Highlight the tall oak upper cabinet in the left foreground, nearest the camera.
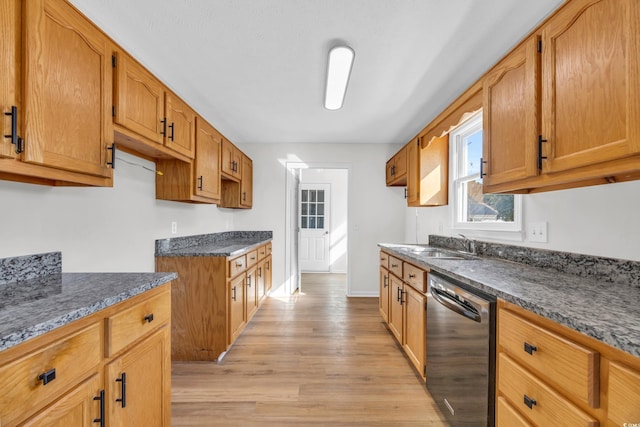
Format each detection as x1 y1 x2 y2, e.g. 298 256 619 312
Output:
0 0 115 186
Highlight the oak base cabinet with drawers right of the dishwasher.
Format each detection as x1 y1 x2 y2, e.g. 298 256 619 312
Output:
496 300 640 426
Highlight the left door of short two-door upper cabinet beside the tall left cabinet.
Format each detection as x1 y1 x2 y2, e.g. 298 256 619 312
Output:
114 52 166 144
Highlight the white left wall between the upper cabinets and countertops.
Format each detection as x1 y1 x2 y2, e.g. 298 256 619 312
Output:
0 151 234 272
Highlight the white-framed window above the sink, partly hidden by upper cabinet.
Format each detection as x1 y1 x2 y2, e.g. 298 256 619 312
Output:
449 112 522 231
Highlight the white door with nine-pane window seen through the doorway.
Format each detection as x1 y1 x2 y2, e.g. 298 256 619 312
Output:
298 183 331 272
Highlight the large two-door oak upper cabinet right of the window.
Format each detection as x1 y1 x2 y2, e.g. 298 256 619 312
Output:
483 0 640 192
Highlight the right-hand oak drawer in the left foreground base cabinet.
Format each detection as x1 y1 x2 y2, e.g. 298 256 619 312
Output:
107 292 171 356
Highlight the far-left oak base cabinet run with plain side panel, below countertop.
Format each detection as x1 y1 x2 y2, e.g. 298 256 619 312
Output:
156 243 272 361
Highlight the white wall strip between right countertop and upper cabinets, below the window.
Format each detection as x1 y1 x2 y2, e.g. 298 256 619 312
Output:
405 181 640 261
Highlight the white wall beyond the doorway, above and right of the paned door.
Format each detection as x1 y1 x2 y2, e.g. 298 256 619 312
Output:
300 169 349 273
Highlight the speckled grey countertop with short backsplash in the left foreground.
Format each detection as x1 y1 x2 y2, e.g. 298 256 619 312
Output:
0 252 177 351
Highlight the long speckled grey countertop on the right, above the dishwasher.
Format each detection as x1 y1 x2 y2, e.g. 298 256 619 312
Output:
379 240 640 357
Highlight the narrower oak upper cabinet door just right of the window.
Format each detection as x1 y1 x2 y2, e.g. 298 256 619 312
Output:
482 36 540 188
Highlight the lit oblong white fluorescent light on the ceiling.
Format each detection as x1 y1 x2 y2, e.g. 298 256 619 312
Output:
324 46 355 110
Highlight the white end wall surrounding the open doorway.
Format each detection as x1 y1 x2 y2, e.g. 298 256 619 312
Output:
234 144 406 296
